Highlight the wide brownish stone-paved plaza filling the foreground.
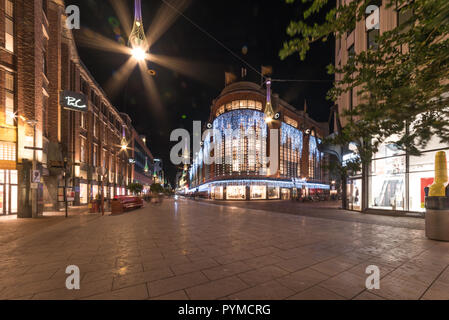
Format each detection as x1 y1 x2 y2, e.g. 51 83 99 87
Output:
0 200 449 300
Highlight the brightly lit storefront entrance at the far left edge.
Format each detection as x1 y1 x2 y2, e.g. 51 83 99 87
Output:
0 170 18 215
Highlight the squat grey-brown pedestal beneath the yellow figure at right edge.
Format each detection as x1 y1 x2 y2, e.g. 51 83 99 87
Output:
425 197 449 241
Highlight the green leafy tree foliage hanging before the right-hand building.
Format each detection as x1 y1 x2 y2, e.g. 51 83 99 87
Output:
280 0 449 163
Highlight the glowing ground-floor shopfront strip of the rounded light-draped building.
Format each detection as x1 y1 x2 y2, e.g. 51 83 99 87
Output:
189 180 330 200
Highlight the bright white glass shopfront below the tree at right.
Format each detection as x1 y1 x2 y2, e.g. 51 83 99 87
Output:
347 139 449 215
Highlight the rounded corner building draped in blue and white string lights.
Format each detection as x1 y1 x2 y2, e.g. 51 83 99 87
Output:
188 81 329 200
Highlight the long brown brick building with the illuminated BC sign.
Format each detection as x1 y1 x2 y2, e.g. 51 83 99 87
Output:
0 0 152 217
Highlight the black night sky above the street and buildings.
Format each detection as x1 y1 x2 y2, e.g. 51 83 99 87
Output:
66 0 334 183
